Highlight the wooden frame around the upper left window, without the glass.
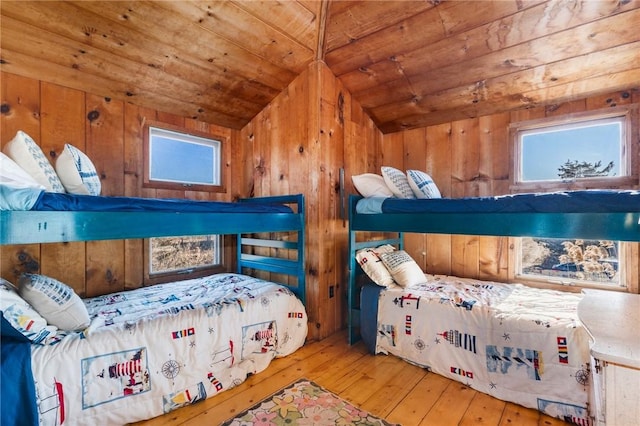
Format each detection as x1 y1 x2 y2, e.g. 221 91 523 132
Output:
142 121 228 193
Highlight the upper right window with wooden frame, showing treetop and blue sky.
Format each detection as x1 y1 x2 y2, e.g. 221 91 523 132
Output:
511 108 632 191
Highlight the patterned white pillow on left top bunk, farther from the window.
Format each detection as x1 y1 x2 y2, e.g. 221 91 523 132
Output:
3 130 64 192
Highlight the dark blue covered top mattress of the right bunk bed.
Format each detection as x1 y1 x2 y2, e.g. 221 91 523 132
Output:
356 190 640 214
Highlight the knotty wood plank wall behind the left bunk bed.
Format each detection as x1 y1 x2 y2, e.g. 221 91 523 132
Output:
0 73 238 297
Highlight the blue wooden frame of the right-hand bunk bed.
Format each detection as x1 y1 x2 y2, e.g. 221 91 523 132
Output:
347 195 640 344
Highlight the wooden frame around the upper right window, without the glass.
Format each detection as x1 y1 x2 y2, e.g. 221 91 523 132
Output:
509 106 638 193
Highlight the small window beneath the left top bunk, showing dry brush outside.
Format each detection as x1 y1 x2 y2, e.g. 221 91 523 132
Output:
145 235 223 283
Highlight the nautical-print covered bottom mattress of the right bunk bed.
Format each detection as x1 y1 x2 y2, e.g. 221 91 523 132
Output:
361 275 590 424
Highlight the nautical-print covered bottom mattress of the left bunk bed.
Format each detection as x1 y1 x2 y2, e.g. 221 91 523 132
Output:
20 274 307 425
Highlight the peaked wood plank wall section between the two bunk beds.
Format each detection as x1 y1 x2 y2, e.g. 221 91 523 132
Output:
240 62 382 339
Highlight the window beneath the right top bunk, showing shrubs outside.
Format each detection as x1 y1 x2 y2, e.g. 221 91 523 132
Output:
516 238 626 289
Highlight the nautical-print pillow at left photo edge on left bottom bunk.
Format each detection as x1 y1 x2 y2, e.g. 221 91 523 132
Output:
0 278 57 344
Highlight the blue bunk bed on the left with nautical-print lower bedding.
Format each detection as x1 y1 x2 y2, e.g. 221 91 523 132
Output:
0 188 307 425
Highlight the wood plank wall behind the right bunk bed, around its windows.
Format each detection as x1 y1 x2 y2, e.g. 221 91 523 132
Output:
382 88 640 291
